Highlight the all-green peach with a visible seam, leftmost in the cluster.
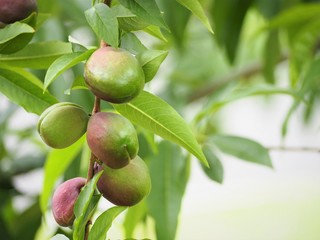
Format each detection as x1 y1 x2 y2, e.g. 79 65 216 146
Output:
38 102 89 148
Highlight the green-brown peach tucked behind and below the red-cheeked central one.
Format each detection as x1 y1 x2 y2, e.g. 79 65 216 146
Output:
95 156 151 206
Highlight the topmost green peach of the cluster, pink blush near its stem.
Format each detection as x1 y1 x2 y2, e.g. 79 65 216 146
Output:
84 47 145 103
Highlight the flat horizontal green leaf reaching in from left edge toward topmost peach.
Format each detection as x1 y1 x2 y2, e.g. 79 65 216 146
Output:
0 41 72 69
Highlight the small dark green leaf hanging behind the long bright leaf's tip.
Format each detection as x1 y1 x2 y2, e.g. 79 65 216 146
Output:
201 145 223 183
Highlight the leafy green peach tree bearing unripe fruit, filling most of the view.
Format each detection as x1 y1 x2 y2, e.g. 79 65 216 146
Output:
0 0 320 240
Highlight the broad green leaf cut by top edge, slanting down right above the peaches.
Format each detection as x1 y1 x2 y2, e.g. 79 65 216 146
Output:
119 0 168 30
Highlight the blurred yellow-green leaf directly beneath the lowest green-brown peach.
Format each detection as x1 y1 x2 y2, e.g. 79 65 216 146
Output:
123 200 147 238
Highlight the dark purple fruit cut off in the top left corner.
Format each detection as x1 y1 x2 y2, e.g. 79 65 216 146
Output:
0 0 38 24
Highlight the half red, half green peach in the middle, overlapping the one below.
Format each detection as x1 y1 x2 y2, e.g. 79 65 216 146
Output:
87 112 139 168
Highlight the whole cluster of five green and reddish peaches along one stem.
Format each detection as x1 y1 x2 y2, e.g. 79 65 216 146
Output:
38 46 151 226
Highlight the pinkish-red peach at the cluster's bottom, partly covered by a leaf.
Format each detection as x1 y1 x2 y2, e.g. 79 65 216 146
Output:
52 177 86 227
